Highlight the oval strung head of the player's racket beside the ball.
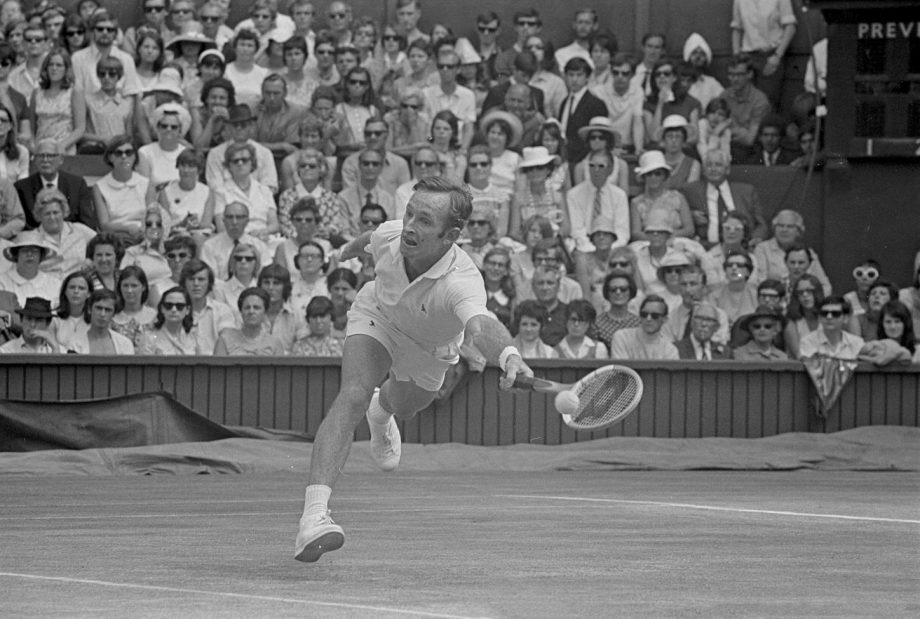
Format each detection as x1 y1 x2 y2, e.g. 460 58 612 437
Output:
560 365 644 432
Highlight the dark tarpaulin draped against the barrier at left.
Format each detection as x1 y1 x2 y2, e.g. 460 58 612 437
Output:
0 393 306 451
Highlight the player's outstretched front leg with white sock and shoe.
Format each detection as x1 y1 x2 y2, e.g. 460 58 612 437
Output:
294 335 390 563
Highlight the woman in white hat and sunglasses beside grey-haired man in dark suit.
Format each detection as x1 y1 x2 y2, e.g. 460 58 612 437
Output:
629 150 696 241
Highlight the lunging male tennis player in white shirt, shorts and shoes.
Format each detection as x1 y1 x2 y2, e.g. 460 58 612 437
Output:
294 177 533 563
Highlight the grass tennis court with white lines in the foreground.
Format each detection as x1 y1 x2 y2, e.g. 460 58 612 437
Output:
0 471 920 617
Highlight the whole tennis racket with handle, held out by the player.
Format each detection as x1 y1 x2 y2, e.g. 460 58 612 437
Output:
514 365 643 431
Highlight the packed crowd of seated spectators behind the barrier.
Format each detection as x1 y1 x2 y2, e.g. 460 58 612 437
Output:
0 0 920 363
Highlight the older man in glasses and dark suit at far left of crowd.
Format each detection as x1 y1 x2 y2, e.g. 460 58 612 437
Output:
14 139 99 230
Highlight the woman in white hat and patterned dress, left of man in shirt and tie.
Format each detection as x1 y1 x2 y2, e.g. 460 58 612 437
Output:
510 146 571 237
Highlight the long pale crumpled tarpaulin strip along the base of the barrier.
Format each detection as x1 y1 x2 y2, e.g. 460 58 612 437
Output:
0 426 920 476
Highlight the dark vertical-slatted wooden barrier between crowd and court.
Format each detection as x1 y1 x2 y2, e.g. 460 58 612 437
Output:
0 355 920 445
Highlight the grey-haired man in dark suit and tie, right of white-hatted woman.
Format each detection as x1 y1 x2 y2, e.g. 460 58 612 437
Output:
681 150 767 249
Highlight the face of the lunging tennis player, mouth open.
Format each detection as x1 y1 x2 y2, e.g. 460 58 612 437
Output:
400 191 460 262
